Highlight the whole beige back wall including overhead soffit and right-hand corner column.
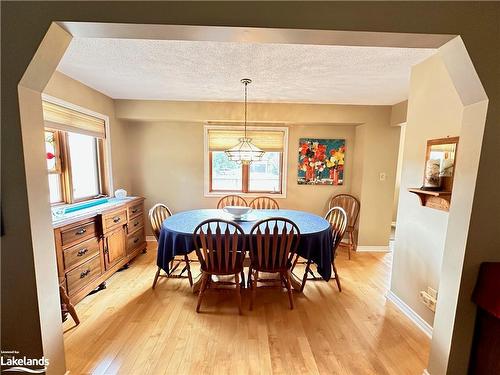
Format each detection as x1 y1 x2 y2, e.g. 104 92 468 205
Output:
116 100 398 246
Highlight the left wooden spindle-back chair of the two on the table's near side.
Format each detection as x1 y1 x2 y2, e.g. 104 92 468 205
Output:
193 219 246 314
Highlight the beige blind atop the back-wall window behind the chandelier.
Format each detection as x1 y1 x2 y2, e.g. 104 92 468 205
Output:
208 128 285 152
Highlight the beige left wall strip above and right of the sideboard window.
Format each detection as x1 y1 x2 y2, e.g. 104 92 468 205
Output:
43 71 130 194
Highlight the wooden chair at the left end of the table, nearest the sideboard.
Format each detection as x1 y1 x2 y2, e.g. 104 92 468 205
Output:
148 203 193 289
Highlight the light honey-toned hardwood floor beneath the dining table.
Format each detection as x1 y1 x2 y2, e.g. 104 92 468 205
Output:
64 243 429 375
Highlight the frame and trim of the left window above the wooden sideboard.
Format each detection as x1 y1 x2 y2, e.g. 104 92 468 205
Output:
42 94 113 207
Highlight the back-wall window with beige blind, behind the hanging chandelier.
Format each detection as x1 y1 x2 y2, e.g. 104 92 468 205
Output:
205 126 287 194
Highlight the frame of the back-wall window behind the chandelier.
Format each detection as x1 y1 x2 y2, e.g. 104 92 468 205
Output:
204 123 288 198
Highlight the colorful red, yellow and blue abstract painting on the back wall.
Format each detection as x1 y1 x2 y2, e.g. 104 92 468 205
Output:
297 138 345 185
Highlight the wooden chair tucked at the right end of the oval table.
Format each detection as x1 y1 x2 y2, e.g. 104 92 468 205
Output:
292 207 347 292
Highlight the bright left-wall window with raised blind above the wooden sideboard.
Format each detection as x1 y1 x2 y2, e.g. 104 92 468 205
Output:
43 102 107 204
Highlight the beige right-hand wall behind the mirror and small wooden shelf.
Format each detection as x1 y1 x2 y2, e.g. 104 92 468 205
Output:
391 55 462 325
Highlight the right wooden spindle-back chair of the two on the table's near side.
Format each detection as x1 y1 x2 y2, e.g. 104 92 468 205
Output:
248 217 300 310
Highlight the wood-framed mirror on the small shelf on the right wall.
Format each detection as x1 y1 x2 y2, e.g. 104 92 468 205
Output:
422 137 458 193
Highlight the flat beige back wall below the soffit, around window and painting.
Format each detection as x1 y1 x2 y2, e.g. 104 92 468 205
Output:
123 122 354 228
